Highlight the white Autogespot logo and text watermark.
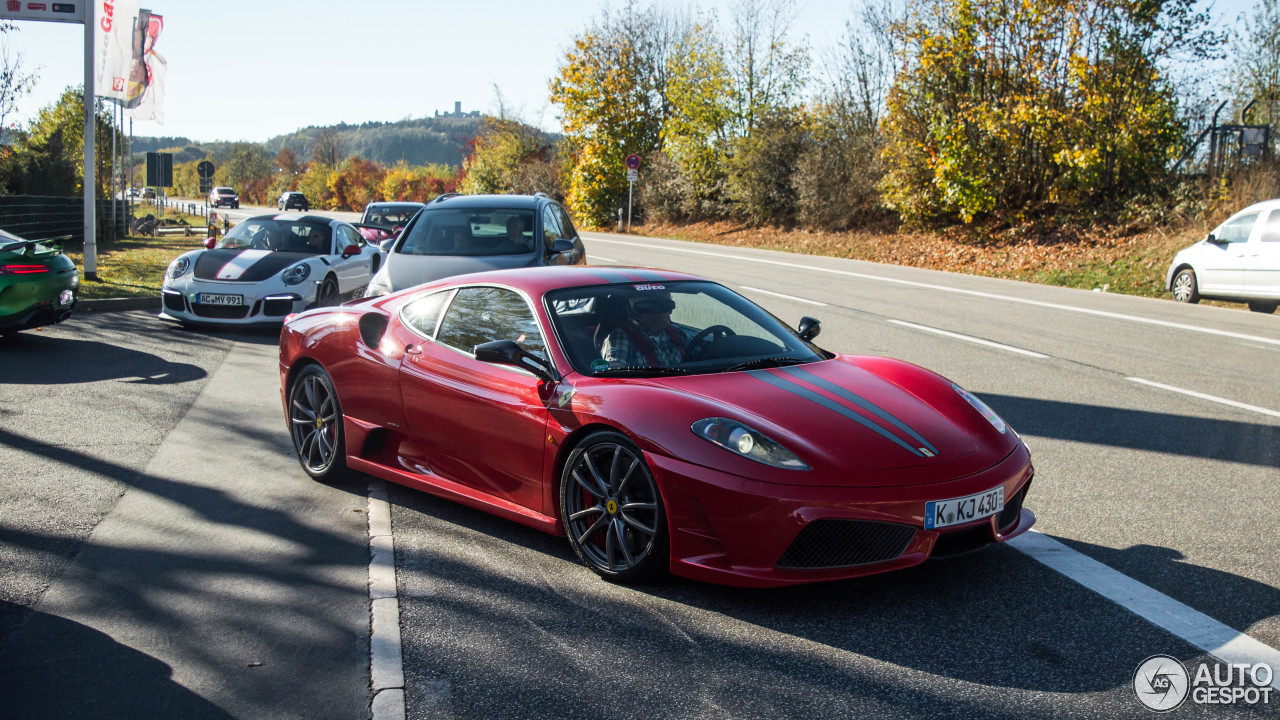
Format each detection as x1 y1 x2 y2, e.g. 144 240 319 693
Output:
1133 655 1275 712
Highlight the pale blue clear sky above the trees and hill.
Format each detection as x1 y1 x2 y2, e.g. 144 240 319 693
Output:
0 0 1253 141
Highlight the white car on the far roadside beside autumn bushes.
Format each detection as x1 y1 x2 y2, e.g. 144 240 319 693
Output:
1165 200 1280 313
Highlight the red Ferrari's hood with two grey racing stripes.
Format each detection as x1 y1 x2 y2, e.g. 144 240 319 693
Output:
645 359 1007 486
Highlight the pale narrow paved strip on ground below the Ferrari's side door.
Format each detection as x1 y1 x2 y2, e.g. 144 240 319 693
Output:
367 478 404 720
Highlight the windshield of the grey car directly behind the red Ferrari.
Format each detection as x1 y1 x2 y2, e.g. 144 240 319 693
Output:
398 208 534 256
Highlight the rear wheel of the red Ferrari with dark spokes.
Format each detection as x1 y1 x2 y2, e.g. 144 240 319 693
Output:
288 365 351 482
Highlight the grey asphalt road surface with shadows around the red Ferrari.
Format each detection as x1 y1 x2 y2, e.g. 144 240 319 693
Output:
0 226 1280 717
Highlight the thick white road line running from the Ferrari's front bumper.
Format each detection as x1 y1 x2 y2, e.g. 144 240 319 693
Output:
1009 530 1280 689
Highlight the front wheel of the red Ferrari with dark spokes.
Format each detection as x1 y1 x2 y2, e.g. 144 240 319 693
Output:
559 432 669 584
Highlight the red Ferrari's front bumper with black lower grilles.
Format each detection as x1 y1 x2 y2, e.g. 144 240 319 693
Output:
646 445 1036 587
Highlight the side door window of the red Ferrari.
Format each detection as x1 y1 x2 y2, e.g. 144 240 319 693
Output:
435 287 547 359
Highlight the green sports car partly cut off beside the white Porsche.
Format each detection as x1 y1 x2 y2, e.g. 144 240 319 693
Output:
0 231 79 334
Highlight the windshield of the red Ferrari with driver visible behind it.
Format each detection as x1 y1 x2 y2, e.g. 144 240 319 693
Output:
545 281 827 377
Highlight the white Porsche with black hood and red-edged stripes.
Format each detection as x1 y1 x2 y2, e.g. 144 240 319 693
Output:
160 214 383 325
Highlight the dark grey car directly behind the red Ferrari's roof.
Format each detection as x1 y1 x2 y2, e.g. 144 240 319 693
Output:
367 193 586 295
